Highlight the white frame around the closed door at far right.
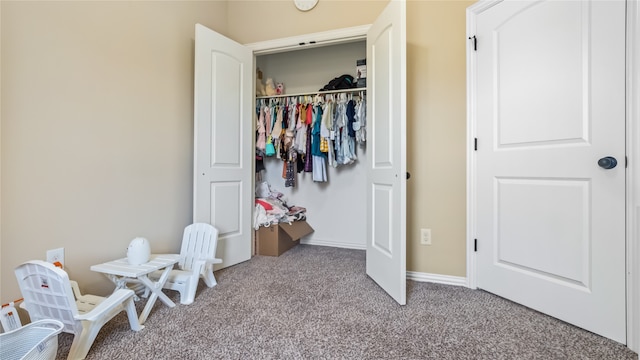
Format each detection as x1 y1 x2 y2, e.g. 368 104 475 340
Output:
466 0 640 353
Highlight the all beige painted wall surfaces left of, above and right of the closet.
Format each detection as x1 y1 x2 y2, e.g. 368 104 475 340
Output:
0 0 472 301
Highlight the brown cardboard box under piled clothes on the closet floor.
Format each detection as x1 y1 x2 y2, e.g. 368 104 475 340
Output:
256 220 313 256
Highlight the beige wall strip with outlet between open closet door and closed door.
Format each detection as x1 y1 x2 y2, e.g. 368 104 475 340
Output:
407 0 475 277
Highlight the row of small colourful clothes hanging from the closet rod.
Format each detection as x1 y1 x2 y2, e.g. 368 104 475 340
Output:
256 92 367 187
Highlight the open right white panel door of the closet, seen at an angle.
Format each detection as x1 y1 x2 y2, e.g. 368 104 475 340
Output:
366 1 407 305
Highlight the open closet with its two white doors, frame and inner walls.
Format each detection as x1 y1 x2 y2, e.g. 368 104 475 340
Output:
193 1 406 304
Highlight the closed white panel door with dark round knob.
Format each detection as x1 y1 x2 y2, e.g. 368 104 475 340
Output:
472 0 626 343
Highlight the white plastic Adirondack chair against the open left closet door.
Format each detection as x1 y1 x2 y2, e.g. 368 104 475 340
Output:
149 223 222 305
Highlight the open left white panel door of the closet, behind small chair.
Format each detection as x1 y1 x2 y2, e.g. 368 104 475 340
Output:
193 24 253 267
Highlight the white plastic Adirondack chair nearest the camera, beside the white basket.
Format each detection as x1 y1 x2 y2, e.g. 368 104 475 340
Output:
15 260 143 359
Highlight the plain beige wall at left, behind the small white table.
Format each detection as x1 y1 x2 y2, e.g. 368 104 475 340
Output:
0 1 227 301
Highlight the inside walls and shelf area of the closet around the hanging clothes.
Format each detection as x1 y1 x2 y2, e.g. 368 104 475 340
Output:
254 40 368 249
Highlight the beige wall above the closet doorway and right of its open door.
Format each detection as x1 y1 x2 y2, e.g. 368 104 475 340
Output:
229 0 474 277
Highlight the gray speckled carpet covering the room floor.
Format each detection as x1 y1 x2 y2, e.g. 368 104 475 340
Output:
57 245 638 359
